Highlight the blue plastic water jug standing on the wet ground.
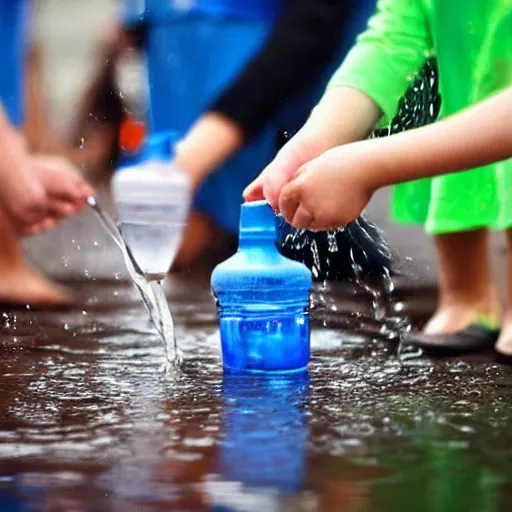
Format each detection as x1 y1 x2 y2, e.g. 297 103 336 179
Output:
211 201 312 372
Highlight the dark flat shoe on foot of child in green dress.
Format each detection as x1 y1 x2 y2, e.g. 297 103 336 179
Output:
403 324 500 356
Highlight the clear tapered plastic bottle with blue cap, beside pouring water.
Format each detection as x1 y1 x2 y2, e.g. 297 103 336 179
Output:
112 134 192 280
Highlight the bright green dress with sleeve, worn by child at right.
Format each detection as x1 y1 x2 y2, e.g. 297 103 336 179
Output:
329 0 512 234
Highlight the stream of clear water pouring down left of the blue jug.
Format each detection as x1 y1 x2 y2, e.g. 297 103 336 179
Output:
88 197 182 369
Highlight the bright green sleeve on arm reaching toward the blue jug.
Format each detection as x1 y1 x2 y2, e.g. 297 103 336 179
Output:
328 0 432 126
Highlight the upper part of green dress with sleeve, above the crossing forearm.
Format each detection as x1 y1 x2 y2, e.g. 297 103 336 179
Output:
329 0 512 127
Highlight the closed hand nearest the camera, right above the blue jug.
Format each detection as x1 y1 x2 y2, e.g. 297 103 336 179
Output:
279 144 375 231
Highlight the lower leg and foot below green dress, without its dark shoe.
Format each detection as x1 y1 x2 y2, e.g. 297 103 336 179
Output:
425 229 501 334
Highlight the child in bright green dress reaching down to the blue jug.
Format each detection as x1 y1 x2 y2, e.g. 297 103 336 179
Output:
245 0 512 352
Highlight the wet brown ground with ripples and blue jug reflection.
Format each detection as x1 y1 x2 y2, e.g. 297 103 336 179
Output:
0 277 512 512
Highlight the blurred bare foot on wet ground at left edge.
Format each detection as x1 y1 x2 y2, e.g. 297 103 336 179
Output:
0 262 70 308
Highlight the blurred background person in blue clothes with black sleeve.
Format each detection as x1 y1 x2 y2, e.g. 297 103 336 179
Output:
67 0 375 269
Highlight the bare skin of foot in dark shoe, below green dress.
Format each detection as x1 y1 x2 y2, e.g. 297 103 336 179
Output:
423 295 502 335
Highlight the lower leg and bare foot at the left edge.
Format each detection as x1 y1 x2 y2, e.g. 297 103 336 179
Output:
0 213 67 306
